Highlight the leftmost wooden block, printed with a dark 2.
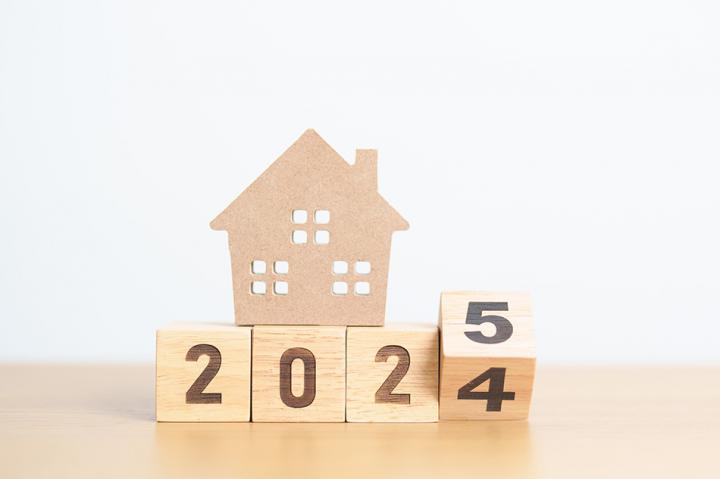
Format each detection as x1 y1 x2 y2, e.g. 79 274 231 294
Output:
155 323 252 422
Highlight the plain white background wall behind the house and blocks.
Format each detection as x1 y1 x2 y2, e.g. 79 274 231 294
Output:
0 0 720 362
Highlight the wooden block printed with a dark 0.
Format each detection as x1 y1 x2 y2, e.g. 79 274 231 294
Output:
252 326 346 422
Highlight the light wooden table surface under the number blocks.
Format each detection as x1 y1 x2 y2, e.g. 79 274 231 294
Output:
0 364 720 479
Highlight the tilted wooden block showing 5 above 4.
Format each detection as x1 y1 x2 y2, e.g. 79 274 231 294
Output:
440 292 535 421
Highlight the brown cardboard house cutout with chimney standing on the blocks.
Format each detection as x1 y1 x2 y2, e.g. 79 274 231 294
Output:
210 130 408 325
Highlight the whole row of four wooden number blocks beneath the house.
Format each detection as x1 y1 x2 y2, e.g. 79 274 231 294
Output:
156 292 535 422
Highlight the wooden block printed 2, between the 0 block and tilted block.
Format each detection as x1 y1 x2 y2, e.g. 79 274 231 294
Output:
346 324 439 422
